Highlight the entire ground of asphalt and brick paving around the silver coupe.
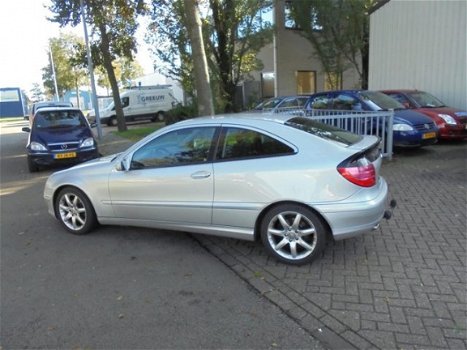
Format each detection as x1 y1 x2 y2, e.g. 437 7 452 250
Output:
1 119 467 349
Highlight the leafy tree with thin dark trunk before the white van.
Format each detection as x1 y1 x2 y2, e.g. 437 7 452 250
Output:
49 0 145 131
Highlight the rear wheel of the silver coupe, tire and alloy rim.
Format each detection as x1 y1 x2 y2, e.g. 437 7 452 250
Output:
261 204 326 265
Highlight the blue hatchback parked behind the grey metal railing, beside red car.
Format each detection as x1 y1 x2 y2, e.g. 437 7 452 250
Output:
306 90 438 147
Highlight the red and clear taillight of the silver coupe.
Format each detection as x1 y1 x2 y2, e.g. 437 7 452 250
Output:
337 158 376 187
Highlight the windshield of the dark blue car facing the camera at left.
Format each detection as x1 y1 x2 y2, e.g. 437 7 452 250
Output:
34 110 86 129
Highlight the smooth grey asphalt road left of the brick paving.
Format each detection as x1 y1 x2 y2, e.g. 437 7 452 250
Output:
0 121 323 350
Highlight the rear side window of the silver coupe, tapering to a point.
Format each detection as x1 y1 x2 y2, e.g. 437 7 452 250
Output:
217 128 294 160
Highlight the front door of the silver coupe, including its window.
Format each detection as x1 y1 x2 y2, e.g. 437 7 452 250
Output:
109 126 216 224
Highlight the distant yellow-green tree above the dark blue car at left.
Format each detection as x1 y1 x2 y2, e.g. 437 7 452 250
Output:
42 33 86 97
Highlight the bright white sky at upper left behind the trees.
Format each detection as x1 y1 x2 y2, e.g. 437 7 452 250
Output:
0 0 157 94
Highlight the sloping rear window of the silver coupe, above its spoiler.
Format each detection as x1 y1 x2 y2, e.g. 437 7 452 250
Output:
285 117 363 146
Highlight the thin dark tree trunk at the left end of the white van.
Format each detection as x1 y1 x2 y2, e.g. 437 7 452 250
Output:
99 24 127 131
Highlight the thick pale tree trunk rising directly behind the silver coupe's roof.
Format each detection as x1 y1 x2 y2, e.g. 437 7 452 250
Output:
184 0 214 116
